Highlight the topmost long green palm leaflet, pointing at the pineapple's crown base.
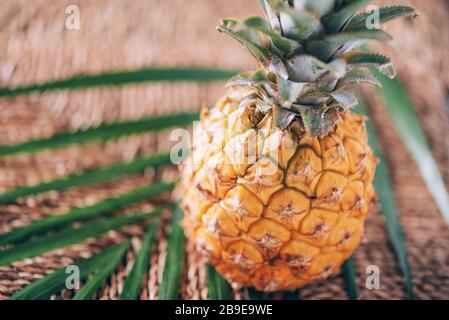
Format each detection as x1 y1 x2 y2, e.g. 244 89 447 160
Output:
0 67 236 97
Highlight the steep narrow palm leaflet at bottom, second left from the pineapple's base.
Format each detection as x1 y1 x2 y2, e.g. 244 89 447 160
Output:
119 218 159 300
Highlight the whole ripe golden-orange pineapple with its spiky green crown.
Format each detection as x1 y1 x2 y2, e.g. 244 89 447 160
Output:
180 0 416 292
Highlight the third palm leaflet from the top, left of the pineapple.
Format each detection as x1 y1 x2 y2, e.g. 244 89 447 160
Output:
0 153 171 203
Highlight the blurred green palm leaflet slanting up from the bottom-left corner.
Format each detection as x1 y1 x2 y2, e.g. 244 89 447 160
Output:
11 242 128 300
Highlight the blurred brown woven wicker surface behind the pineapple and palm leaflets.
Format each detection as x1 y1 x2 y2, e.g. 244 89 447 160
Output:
0 0 449 299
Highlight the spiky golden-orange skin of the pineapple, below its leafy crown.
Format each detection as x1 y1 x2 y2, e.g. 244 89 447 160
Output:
180 88 377 292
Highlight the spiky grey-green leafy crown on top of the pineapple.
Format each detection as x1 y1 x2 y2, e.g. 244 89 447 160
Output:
218 0 417 136
